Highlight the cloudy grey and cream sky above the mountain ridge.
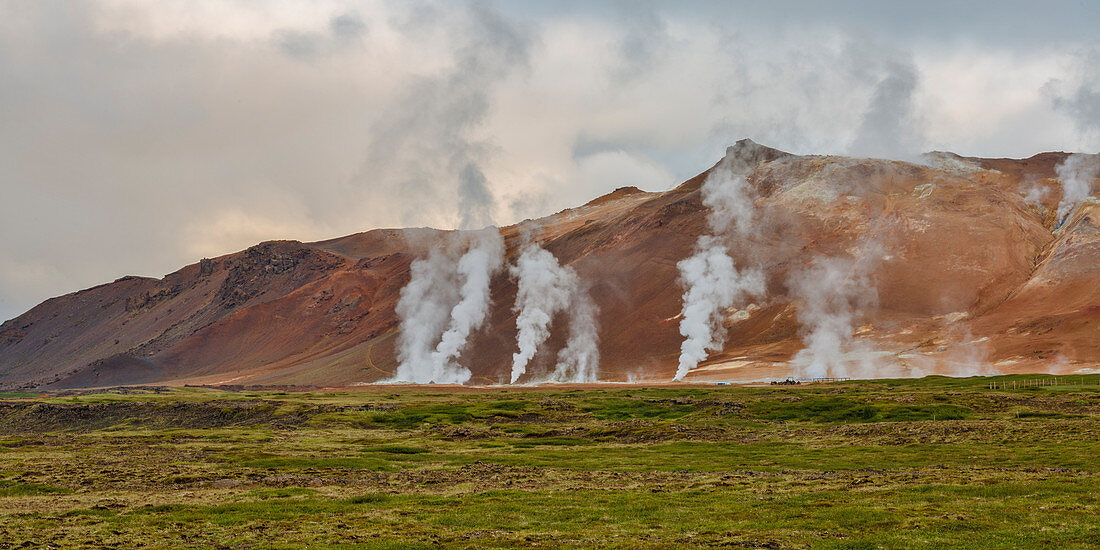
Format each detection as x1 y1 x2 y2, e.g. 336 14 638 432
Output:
0 0 1100 320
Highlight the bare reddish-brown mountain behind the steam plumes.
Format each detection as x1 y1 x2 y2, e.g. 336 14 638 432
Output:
0 140 1100 388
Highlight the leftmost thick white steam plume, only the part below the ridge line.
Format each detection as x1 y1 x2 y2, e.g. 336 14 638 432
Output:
393 228 504 384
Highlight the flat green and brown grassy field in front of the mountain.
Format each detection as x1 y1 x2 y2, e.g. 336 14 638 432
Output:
0 375 1100 549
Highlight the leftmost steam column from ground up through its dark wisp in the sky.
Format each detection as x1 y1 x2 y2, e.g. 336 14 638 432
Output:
385 32 508 384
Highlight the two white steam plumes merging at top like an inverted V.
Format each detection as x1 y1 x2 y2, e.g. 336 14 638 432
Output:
510 243 600 383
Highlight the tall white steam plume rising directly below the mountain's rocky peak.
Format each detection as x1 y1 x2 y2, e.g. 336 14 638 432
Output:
673 156 765 381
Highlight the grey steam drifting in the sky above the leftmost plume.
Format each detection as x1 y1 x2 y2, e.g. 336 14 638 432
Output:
356 2 529 229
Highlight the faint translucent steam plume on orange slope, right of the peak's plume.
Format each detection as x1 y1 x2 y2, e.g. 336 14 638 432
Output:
788 246 881 378
